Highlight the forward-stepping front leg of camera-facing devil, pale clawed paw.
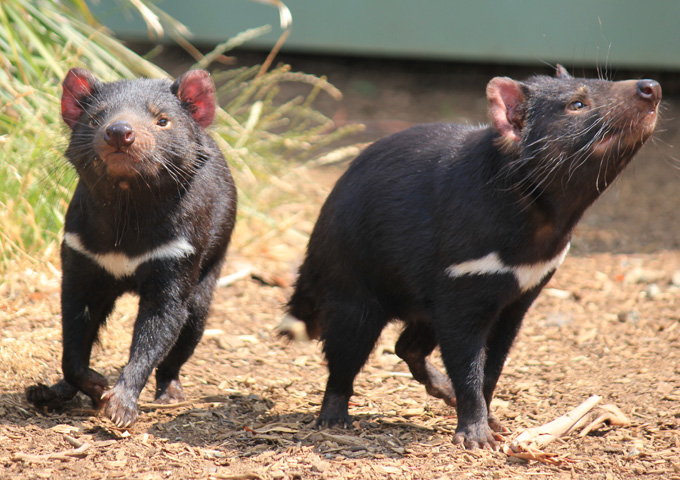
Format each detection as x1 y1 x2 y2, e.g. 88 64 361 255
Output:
102 275 188 428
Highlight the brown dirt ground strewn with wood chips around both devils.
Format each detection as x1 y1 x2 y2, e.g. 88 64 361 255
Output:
0 55 680 480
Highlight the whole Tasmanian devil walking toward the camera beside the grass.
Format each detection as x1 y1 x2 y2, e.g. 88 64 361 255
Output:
26 69 236 427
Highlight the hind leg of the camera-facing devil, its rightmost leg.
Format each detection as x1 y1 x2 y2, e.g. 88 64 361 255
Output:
155 265 220 404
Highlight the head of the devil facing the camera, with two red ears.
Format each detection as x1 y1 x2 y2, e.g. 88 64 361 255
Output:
61 68 216 195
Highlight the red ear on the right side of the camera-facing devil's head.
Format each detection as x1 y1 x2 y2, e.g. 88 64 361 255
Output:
171 70 215 128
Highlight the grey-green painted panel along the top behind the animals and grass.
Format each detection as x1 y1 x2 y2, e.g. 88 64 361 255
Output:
93 0 680 69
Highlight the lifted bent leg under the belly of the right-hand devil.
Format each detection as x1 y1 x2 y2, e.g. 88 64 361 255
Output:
395 321 456 407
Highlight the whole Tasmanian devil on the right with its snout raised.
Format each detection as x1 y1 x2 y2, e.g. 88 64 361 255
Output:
282 66 661 448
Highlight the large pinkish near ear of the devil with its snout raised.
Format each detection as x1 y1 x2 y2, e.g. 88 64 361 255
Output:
486 77 526 143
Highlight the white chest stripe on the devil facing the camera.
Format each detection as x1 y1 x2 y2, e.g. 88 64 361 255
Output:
64 233 195 278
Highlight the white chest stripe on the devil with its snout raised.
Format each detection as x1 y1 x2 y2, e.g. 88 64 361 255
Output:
446 244 569 292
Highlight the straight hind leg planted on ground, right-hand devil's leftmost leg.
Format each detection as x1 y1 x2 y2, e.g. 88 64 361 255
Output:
316 302 387 427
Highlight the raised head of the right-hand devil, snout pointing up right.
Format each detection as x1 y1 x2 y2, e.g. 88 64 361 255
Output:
486 65 661 194
